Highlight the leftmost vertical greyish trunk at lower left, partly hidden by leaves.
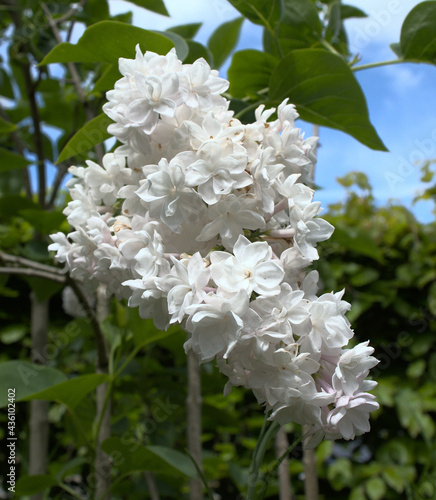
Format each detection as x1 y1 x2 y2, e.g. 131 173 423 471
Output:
29 292 49 500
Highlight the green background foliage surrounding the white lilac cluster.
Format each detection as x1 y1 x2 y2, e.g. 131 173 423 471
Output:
0 0 436 500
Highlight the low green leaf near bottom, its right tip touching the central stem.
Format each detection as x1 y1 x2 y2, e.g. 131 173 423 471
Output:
102 437 196 477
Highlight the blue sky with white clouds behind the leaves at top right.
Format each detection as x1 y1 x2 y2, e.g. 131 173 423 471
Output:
109 0 436 222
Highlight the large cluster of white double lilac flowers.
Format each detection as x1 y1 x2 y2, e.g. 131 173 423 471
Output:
50 49 378 441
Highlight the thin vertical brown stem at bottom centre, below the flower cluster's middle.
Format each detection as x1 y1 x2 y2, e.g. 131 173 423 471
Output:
186 349 203 500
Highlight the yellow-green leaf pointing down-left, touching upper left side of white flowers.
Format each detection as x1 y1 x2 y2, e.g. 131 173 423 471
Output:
57 113 112 163
